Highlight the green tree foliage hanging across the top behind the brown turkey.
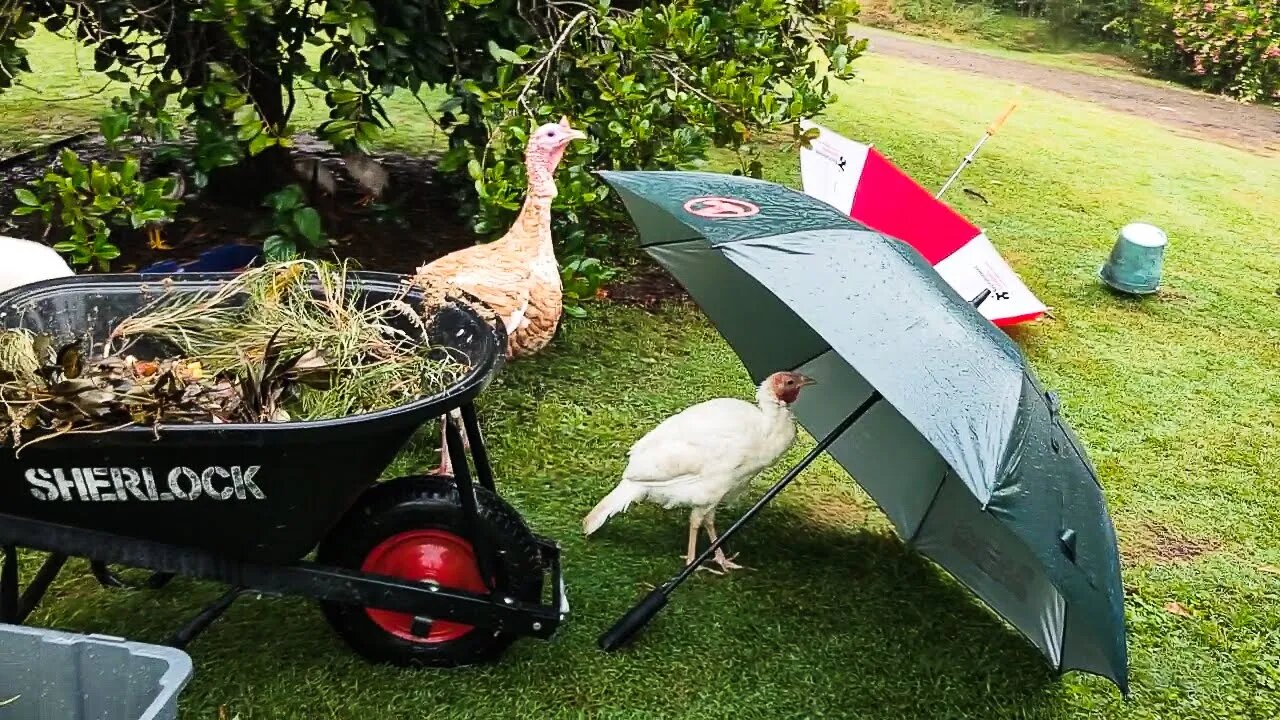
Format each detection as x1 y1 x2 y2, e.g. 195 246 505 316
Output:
0 0 863 274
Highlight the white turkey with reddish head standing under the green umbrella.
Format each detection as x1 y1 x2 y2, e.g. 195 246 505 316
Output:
582 373 814 570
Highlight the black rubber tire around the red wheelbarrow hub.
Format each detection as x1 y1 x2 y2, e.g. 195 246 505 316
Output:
316 475 544 667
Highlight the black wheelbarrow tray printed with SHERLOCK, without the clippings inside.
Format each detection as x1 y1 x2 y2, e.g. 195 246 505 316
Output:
0 272 504 564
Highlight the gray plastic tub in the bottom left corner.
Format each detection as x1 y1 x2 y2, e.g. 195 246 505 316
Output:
0 625 191 720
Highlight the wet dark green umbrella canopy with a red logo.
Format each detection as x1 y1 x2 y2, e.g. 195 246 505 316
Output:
600 166 1128 692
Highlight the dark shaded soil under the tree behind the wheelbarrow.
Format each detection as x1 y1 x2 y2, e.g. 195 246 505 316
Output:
0 131 476 273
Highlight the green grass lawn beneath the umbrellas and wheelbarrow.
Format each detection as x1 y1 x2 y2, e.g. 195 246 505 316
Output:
0 29 1280 720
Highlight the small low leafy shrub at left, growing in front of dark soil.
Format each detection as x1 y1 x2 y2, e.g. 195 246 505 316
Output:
13 150 179 270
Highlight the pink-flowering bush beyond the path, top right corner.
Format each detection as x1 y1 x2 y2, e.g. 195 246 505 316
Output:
1129 0 1280 101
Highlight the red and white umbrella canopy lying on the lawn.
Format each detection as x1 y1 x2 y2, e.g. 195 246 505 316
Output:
800 120 1046 325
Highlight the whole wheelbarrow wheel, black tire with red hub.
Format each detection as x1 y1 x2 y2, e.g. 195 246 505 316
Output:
316 475 543 667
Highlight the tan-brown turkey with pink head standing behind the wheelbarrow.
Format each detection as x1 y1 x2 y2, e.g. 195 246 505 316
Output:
413 118 586 475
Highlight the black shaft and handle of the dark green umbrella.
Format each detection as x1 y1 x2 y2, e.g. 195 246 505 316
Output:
599 391 884 651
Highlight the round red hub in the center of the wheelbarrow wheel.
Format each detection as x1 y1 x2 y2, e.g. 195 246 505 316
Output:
360 530 485 643
